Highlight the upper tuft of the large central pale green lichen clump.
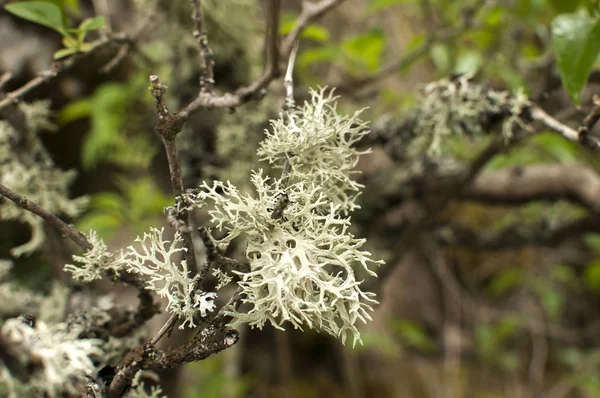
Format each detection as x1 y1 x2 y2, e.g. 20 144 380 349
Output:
258 88 369 215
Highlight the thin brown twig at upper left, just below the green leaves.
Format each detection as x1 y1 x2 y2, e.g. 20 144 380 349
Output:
0 33 131 110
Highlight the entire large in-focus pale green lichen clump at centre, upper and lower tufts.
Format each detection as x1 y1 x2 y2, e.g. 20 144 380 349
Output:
186 90 380 343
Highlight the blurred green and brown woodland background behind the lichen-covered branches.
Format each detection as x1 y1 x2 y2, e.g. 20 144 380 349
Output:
0 0 600 398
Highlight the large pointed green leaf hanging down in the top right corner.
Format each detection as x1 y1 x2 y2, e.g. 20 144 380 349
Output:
551 14 600 105
